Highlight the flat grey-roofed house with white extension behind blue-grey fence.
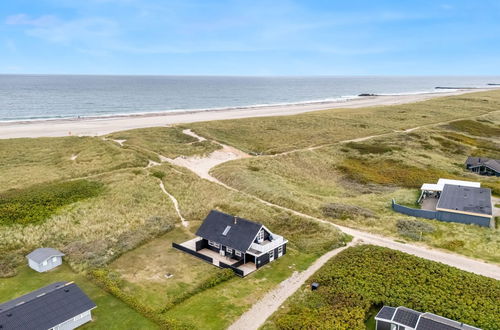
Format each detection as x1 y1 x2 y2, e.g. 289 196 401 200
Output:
392 179 494 227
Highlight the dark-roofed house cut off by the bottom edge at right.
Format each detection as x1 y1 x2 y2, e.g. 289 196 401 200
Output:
375 306 480 330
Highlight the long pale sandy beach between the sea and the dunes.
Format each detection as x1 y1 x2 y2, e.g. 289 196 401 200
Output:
0 89 487 139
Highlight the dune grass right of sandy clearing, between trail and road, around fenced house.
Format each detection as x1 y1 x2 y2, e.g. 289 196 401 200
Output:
212 122 500 263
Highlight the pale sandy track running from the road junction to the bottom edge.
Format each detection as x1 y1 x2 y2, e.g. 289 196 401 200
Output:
228 240 357 330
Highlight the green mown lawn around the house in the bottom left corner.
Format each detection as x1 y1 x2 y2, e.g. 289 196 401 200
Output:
0 264 158 329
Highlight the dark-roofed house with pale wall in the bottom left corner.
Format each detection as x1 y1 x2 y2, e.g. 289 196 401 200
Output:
0 282 97 330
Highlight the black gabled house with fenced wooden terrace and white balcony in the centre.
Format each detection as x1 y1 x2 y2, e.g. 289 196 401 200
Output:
173 210 288 276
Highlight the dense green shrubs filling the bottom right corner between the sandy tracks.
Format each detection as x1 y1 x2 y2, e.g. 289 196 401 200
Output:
263 245 500 330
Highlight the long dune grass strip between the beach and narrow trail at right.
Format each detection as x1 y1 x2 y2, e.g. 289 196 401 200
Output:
186 91 500 154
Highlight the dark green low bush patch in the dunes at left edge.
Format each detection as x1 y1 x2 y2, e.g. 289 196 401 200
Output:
0 180 103 225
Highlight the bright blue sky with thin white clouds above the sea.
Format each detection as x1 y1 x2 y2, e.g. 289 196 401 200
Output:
0 0 500 76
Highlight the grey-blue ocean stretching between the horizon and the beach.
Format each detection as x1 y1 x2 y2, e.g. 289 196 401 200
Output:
0 75 500 121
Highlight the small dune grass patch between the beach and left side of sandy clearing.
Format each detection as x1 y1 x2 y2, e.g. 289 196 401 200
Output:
107 127 220 160
